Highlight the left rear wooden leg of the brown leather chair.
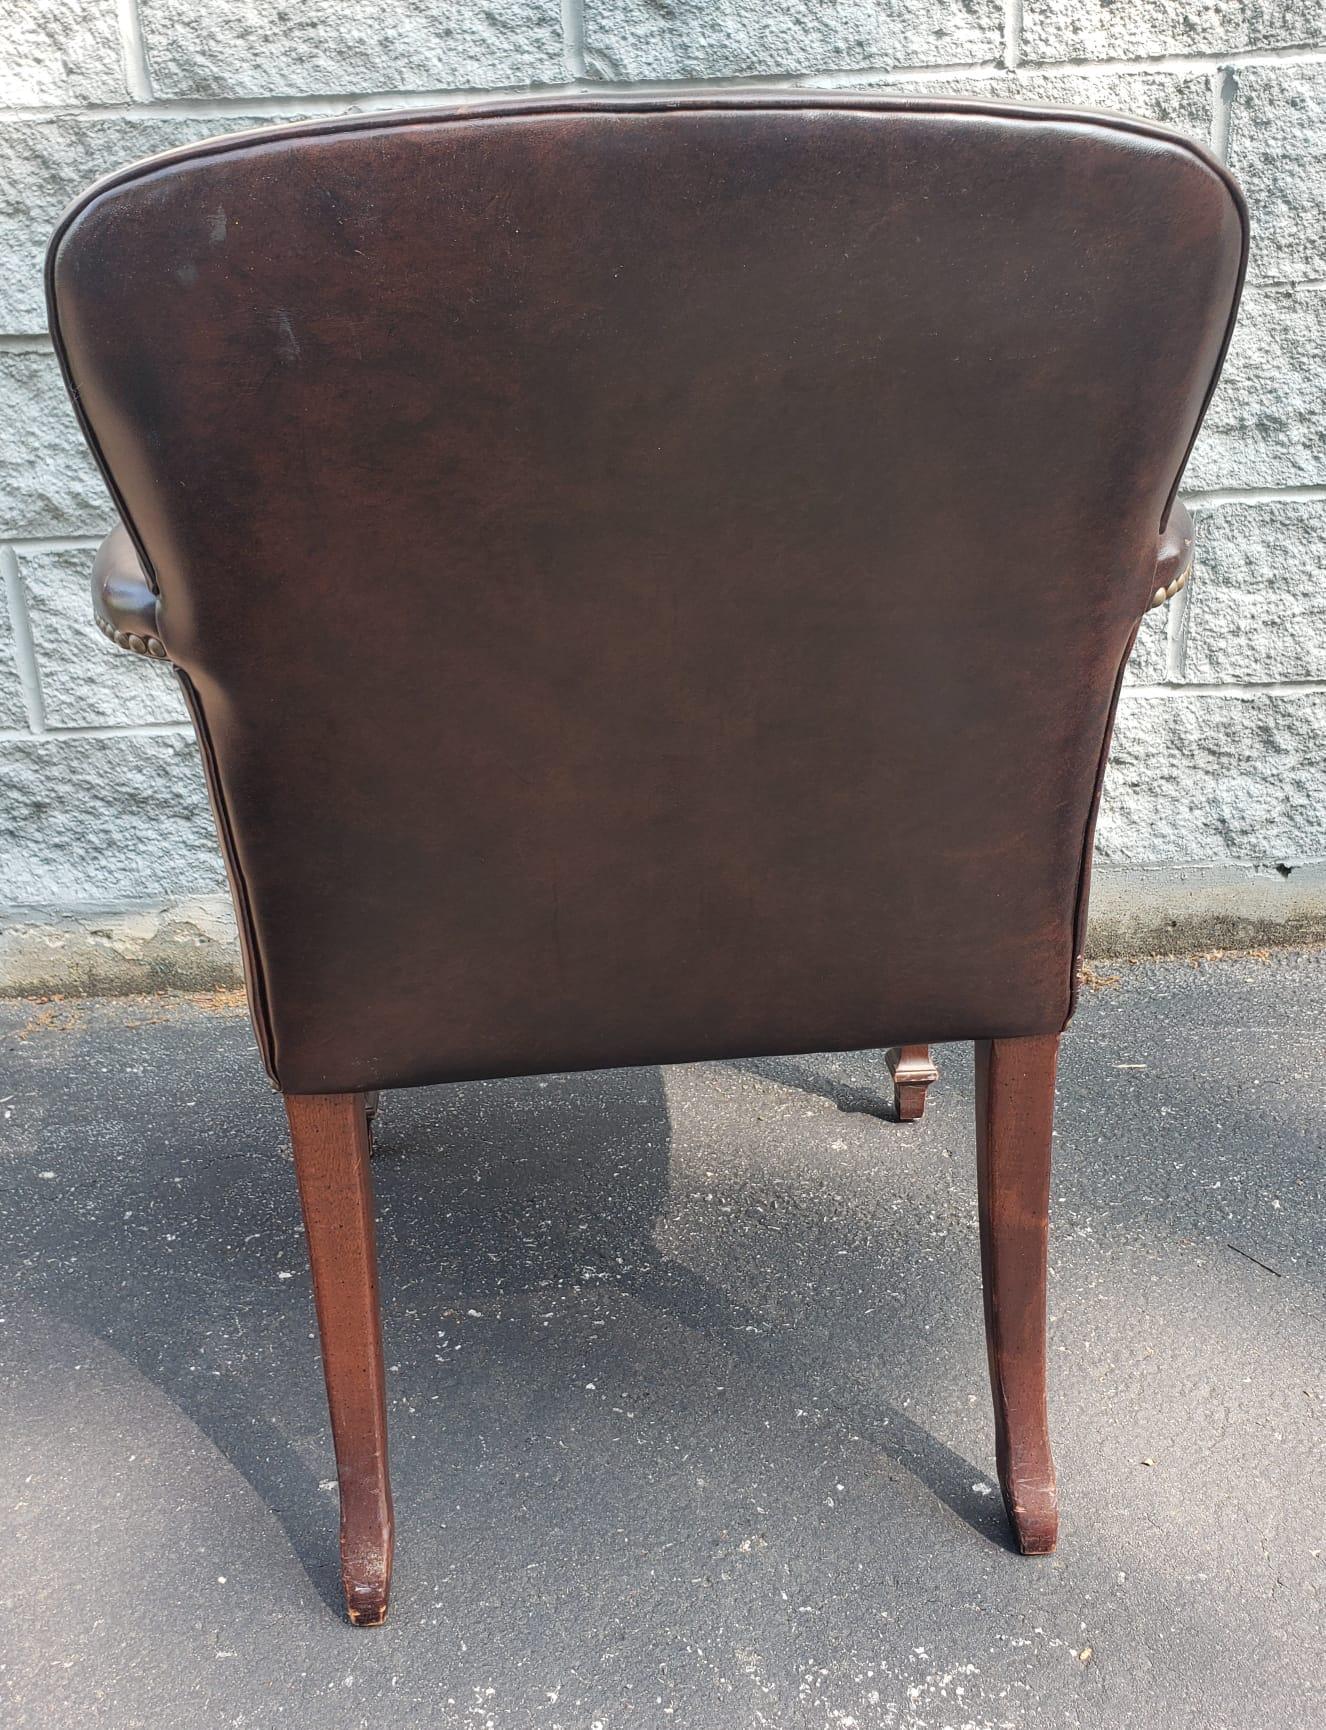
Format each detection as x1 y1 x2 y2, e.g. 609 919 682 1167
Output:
286 1093 393 1628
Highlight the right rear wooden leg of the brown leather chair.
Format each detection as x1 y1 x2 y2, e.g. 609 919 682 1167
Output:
976 1035 1059 1555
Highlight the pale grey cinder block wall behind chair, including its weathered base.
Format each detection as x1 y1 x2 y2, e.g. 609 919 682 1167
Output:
0 0 1326 988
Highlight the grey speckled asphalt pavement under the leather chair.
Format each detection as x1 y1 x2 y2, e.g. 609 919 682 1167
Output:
0 952 1326 1730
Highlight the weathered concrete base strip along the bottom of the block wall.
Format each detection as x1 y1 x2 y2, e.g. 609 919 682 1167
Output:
0 862 1326 996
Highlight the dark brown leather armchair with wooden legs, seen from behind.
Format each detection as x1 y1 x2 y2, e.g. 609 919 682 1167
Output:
48 93 1246 1623
